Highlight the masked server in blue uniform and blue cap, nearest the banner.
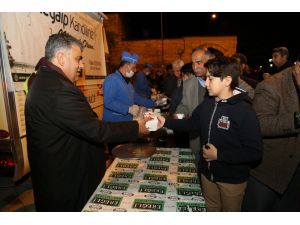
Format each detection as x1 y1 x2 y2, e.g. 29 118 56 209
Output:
103 51 156 121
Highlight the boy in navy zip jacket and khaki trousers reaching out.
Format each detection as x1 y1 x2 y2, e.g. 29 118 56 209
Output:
158 57 262 211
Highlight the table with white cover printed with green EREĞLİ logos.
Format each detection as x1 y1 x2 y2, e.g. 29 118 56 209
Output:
82 147 206 212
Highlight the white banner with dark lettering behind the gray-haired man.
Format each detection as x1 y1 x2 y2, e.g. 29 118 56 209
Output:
0 12 106 79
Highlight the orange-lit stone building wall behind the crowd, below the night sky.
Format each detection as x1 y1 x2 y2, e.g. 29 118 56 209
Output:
104 13 237 72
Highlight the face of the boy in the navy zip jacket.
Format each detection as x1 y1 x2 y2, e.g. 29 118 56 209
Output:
205 74 228 97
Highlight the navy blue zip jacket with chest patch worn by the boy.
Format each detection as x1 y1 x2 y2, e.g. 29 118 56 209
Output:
165 93 263 184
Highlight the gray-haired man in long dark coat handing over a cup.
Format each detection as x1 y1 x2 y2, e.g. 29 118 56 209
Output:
25 34 147 211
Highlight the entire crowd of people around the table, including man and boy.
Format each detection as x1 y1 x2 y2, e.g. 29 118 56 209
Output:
25 34 300 211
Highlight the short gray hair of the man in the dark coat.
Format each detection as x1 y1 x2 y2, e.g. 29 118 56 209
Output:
45 33 83 61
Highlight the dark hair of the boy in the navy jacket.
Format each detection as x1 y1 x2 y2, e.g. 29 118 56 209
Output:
204 56 241 90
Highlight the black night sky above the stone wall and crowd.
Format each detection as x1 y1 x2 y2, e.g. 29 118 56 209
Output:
121 12 300 67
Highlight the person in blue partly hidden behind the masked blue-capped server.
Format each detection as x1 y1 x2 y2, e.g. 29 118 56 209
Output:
134 63 152 98
